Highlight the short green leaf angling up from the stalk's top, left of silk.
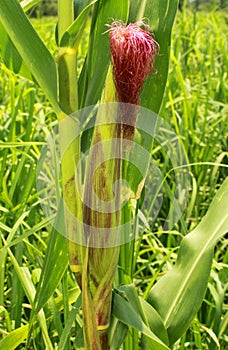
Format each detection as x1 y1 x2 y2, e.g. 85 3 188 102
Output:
60 0 97 50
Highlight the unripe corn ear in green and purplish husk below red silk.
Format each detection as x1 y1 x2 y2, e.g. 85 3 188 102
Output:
82 69 121 349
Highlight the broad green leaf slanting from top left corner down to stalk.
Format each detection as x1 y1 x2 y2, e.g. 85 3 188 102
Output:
0 0 60 112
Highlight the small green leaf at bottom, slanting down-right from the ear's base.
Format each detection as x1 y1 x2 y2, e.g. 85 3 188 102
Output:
113 291 169 350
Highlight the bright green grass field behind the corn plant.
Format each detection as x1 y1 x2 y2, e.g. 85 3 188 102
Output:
0 6 228 350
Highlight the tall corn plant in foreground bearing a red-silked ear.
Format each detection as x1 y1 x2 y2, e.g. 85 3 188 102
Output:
0 0 228 350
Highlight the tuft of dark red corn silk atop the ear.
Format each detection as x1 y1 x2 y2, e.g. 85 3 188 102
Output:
109 22 159 139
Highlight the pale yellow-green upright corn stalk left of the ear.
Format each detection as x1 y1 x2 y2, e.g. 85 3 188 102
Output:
58 0 80 279
